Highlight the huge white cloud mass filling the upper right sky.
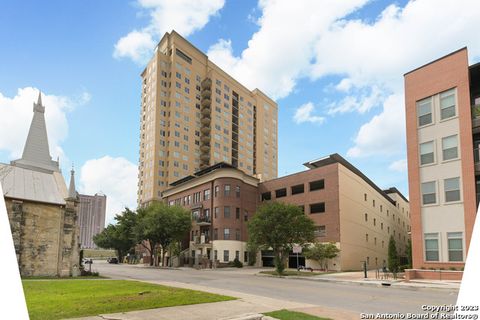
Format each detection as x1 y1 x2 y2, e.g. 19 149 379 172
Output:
208 0 480 156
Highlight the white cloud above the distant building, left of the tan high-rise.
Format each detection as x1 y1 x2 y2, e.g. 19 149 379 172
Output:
78 156 138 223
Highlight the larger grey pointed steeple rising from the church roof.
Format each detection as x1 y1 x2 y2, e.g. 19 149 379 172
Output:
12 92 60 172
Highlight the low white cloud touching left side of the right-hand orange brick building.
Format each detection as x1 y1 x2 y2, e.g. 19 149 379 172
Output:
347 94 405 157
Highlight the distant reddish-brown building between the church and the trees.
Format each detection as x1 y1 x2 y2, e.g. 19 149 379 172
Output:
78 193 107 249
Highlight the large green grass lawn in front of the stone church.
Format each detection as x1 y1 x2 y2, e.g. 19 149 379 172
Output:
23 280 235 320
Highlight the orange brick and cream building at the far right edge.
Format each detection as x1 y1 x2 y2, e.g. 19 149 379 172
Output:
405 48 480 279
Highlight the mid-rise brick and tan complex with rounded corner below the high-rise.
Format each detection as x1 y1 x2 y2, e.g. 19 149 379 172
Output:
163 154 410 270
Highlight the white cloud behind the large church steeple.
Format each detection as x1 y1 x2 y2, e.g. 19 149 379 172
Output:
0 87 91 162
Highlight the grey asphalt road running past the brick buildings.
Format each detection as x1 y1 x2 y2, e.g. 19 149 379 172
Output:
92 261 458 313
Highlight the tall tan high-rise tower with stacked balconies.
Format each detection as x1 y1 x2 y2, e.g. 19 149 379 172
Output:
138 31 278 204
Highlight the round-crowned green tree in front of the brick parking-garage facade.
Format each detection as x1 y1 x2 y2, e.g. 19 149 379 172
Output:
248 201 315 274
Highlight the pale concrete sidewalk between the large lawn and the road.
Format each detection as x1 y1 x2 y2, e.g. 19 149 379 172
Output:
71 281 358 320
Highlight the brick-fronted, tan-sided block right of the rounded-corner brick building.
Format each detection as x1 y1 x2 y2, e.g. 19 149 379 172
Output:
258 154 410 270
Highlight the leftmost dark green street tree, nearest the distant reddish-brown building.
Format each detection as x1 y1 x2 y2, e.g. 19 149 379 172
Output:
93 208 137 261
